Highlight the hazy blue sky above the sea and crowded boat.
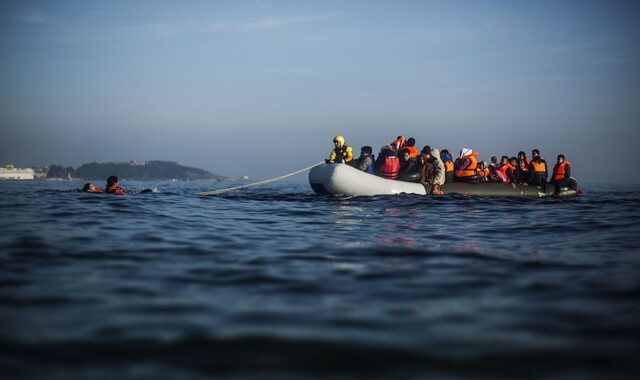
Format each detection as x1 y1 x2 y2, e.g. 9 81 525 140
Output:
0 0 640 183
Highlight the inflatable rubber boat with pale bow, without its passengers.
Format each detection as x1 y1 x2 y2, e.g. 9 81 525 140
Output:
309 164 578 198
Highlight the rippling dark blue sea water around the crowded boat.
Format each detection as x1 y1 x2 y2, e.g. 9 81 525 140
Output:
0 181 640 379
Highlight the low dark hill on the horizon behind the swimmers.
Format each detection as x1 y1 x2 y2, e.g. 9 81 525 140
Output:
47 161 225 181
